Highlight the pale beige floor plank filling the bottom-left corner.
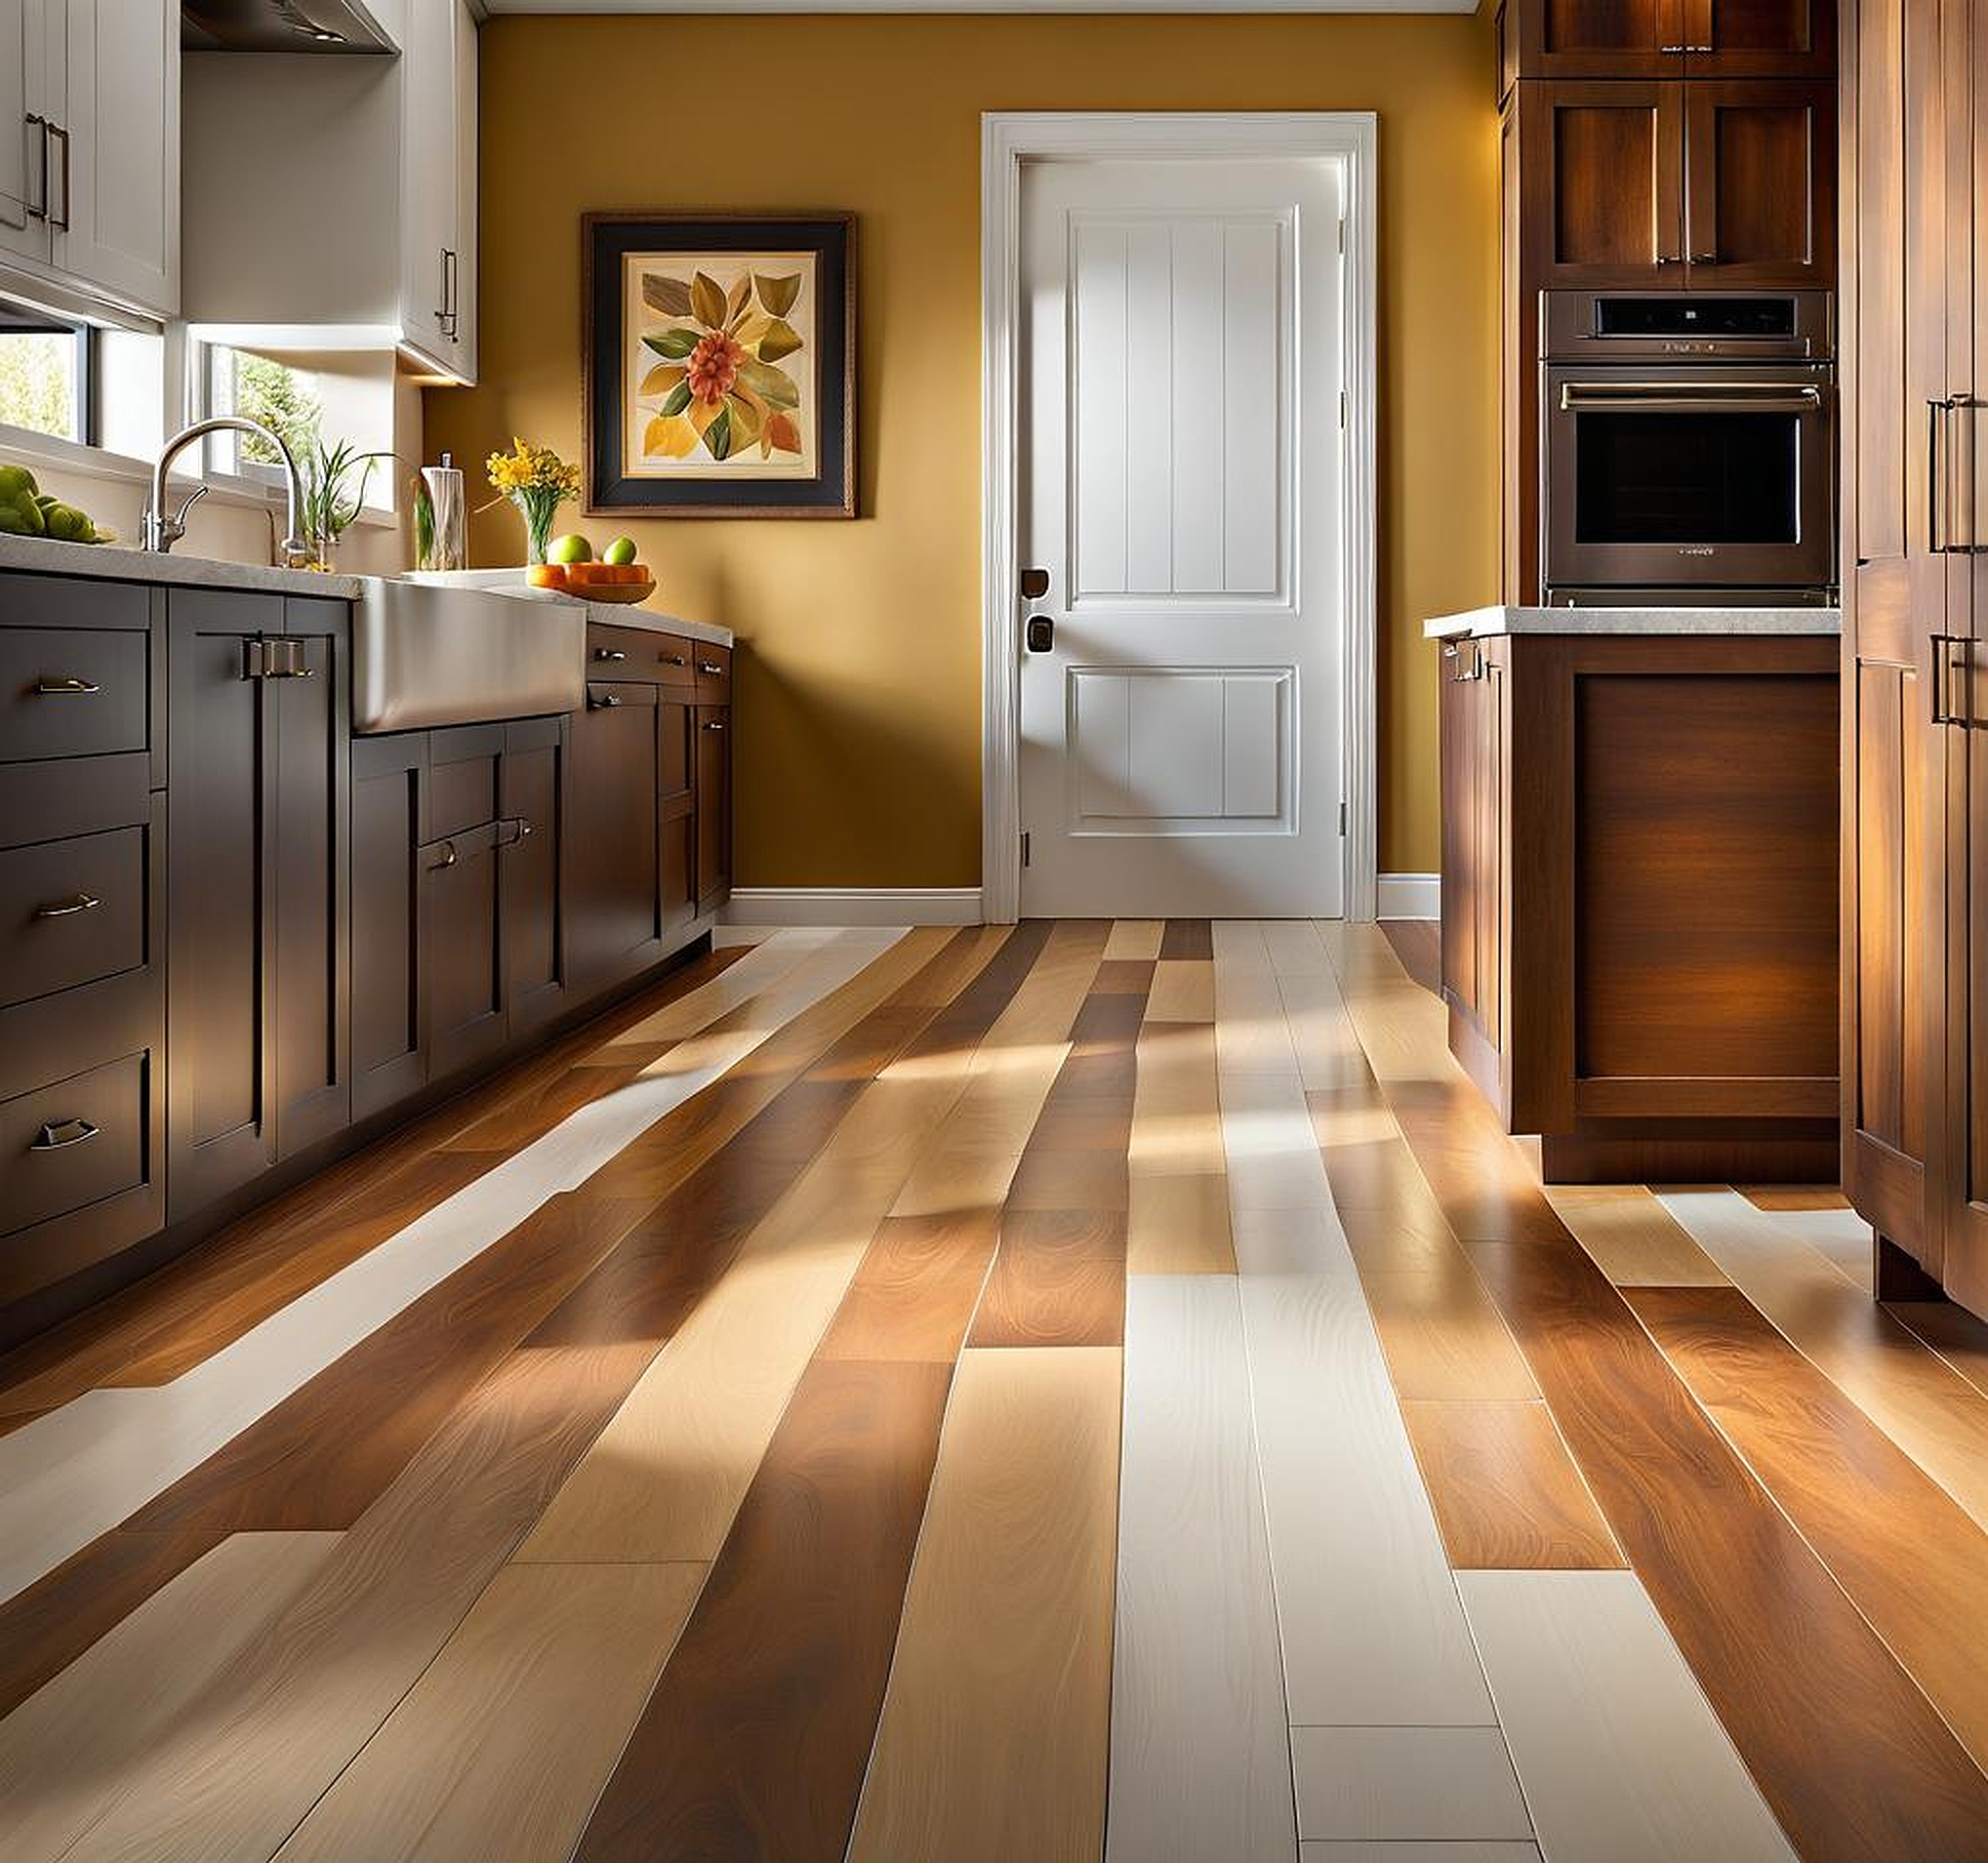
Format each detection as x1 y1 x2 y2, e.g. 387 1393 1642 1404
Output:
0 1533 342 1863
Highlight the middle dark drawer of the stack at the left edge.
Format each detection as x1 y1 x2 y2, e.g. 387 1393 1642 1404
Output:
0 828 147 1008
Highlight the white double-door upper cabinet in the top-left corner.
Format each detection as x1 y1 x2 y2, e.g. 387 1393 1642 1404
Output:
0 0 179 316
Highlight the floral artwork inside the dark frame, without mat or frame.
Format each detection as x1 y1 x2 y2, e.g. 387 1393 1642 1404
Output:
623 253 819 479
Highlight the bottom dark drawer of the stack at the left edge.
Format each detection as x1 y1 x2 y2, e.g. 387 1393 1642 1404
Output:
0 1054 147 1235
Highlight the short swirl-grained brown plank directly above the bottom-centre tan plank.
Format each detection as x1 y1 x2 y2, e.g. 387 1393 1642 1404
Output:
968 1216 1125 1346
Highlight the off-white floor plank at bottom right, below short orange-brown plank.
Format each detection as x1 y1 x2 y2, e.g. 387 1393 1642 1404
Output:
1457 1573 1793 1863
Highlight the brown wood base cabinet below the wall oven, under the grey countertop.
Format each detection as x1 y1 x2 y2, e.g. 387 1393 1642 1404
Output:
1441 610 1839 1183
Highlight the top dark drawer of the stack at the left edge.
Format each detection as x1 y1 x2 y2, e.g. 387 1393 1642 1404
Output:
0 628 151 763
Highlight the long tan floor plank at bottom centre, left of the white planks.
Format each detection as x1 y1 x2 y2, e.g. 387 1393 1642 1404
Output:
849 1346 1121 1863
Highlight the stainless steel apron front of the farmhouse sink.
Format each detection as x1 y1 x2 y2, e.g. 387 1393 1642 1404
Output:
352 577 587 732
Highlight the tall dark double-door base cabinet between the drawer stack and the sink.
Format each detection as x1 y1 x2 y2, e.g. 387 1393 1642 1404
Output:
167 588 352 1219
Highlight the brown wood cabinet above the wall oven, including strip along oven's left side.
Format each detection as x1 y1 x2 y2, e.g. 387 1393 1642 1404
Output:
1499 0 1837 602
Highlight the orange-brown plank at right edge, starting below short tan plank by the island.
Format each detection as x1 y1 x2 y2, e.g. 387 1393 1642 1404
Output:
1624 1286 1988 1763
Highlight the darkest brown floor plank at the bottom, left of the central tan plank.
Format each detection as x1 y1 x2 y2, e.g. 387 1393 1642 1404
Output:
575 1360 951 1863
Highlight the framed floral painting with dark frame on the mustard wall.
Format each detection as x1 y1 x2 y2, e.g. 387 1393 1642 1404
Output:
583 213 857 517
